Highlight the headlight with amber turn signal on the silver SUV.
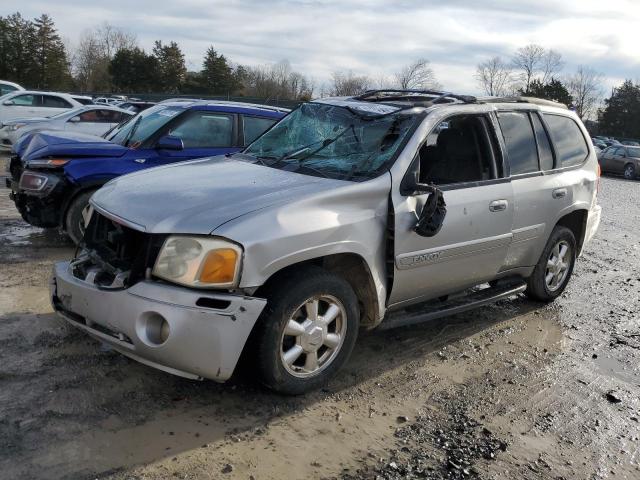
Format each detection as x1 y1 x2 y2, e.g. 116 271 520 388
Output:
153 236 242 288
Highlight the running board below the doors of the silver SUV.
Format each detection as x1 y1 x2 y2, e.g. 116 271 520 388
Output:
378 281 527 330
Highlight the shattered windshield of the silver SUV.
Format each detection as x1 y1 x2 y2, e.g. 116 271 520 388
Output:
239 103 417 181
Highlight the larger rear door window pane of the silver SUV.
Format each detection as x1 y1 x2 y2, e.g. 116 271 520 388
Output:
498 112 539 175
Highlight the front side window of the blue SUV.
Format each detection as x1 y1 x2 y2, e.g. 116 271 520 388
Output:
169 112 234 148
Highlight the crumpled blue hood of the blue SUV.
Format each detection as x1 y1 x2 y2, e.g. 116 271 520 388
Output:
14 130 129 160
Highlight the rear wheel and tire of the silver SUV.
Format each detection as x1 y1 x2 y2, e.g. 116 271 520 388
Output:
525 226 577 303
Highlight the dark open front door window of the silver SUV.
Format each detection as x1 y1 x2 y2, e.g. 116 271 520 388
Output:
418 115 501 185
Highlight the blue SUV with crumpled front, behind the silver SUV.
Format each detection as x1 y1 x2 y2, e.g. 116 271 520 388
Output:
7 101 286 242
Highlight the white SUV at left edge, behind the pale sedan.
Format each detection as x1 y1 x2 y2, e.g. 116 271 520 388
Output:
0 90 82 123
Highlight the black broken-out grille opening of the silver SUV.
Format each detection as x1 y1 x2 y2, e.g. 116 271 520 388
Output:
73 211 166 289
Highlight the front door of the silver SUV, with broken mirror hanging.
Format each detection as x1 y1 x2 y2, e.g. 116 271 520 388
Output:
389 114 513 306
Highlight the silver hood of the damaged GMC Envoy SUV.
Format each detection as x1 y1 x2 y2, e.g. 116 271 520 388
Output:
91 156 350 235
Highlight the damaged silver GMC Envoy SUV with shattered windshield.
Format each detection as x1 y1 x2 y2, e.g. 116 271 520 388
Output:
52 90 601 394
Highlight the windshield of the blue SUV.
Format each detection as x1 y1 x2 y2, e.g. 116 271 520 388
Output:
106 105 185 148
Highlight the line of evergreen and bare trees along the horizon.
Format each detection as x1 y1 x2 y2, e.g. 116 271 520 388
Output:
0 13 640 138
